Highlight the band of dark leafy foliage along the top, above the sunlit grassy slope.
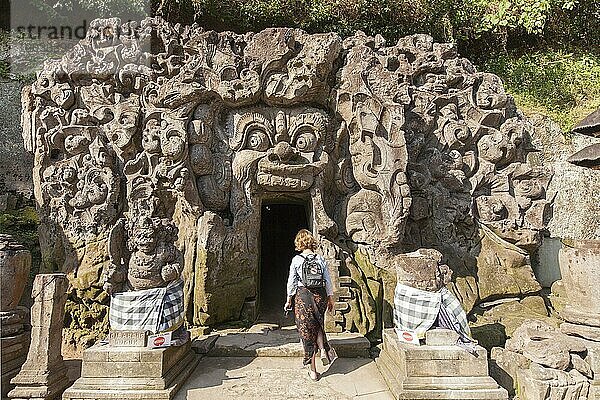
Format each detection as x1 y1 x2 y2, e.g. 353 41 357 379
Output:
153 0 600 53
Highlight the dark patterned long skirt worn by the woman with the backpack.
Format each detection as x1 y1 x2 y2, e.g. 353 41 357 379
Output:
294 286 329 365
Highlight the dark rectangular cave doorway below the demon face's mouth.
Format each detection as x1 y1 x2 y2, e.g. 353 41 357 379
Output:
258 203 310 326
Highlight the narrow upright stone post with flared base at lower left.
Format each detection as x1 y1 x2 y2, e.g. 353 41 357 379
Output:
8 273 70 400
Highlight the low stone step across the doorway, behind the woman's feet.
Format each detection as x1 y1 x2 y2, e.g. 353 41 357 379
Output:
192 329 371 358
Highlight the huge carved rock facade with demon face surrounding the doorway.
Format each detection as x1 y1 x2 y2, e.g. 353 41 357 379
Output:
23 18 550 340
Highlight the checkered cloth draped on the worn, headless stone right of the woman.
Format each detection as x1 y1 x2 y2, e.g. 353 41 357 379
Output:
394 284 471 338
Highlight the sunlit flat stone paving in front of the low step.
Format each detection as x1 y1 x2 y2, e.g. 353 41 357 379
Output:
175 357 393 400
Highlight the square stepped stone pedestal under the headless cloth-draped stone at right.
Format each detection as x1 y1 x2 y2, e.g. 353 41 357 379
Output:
375 329 508 400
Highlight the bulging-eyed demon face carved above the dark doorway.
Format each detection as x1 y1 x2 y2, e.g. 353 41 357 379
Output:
218 107 337 235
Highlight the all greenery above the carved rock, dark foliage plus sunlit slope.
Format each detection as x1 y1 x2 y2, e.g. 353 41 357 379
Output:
0 0 600 129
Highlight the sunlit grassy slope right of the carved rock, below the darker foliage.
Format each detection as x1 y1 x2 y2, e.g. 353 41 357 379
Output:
480 50 600 131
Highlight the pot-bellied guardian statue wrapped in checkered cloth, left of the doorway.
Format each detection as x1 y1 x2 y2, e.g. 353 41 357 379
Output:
103 214 189 334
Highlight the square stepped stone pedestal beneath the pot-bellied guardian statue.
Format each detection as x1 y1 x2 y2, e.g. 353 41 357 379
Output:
62 342 198 400
